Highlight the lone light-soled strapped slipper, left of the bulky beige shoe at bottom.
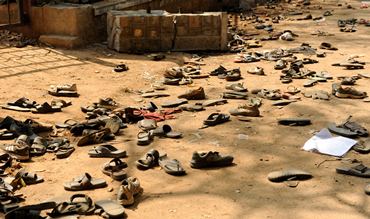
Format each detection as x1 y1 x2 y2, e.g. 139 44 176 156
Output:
64 173 107 191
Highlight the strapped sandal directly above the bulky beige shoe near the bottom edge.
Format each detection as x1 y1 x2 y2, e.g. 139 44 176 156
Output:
102 158 127 181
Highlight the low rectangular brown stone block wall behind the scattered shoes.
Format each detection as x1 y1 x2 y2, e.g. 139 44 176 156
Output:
107 10 227 52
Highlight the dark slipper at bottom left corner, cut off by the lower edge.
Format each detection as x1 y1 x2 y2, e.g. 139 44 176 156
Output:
5 202 56 219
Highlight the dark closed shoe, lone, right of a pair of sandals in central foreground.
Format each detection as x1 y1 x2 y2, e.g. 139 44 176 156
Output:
190 151 234 169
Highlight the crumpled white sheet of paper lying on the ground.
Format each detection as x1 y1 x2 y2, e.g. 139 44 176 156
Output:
303 128 357 157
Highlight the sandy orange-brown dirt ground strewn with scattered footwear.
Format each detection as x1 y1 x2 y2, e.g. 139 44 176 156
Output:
0 1 370 218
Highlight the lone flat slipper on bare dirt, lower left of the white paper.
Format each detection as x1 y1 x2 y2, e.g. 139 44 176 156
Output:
267 169 312 182
